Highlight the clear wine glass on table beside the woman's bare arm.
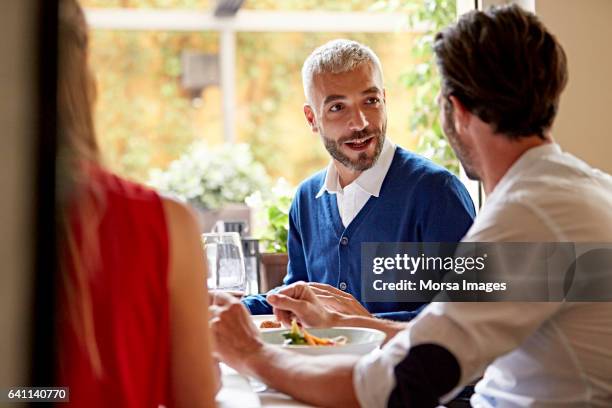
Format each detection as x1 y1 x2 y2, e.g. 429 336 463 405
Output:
202 232 246 293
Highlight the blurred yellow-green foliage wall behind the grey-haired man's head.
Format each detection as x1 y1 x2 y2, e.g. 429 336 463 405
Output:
83 0 458 185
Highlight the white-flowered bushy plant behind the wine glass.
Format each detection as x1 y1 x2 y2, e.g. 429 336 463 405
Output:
148 142 270 231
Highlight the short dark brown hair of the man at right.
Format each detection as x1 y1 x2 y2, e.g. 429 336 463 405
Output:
434 5 568 138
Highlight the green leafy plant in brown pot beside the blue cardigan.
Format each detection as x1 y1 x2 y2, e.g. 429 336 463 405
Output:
245 179 294 293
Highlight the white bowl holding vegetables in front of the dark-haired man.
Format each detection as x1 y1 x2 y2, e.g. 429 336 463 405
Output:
261 327 386 355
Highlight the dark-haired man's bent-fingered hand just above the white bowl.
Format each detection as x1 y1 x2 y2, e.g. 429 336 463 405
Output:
267 282 338 327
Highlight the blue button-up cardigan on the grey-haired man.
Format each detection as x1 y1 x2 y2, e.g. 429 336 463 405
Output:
243 146 475 321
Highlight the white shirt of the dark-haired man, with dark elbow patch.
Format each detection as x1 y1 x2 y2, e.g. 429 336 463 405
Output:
353 144 612 408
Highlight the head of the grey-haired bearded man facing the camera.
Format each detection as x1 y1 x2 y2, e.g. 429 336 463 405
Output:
302 40 387 171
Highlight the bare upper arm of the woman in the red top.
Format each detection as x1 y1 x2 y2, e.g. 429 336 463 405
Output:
163 199 220 407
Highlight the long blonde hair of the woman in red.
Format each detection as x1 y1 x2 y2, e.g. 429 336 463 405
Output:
57 0 104 377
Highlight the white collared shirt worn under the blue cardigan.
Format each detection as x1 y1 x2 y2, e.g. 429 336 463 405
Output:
316 138 395 228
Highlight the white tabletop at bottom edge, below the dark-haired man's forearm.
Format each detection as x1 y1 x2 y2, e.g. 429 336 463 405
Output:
217 363 312 408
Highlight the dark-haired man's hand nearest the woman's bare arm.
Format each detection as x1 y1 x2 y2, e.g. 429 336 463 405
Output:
209 293 263 371
